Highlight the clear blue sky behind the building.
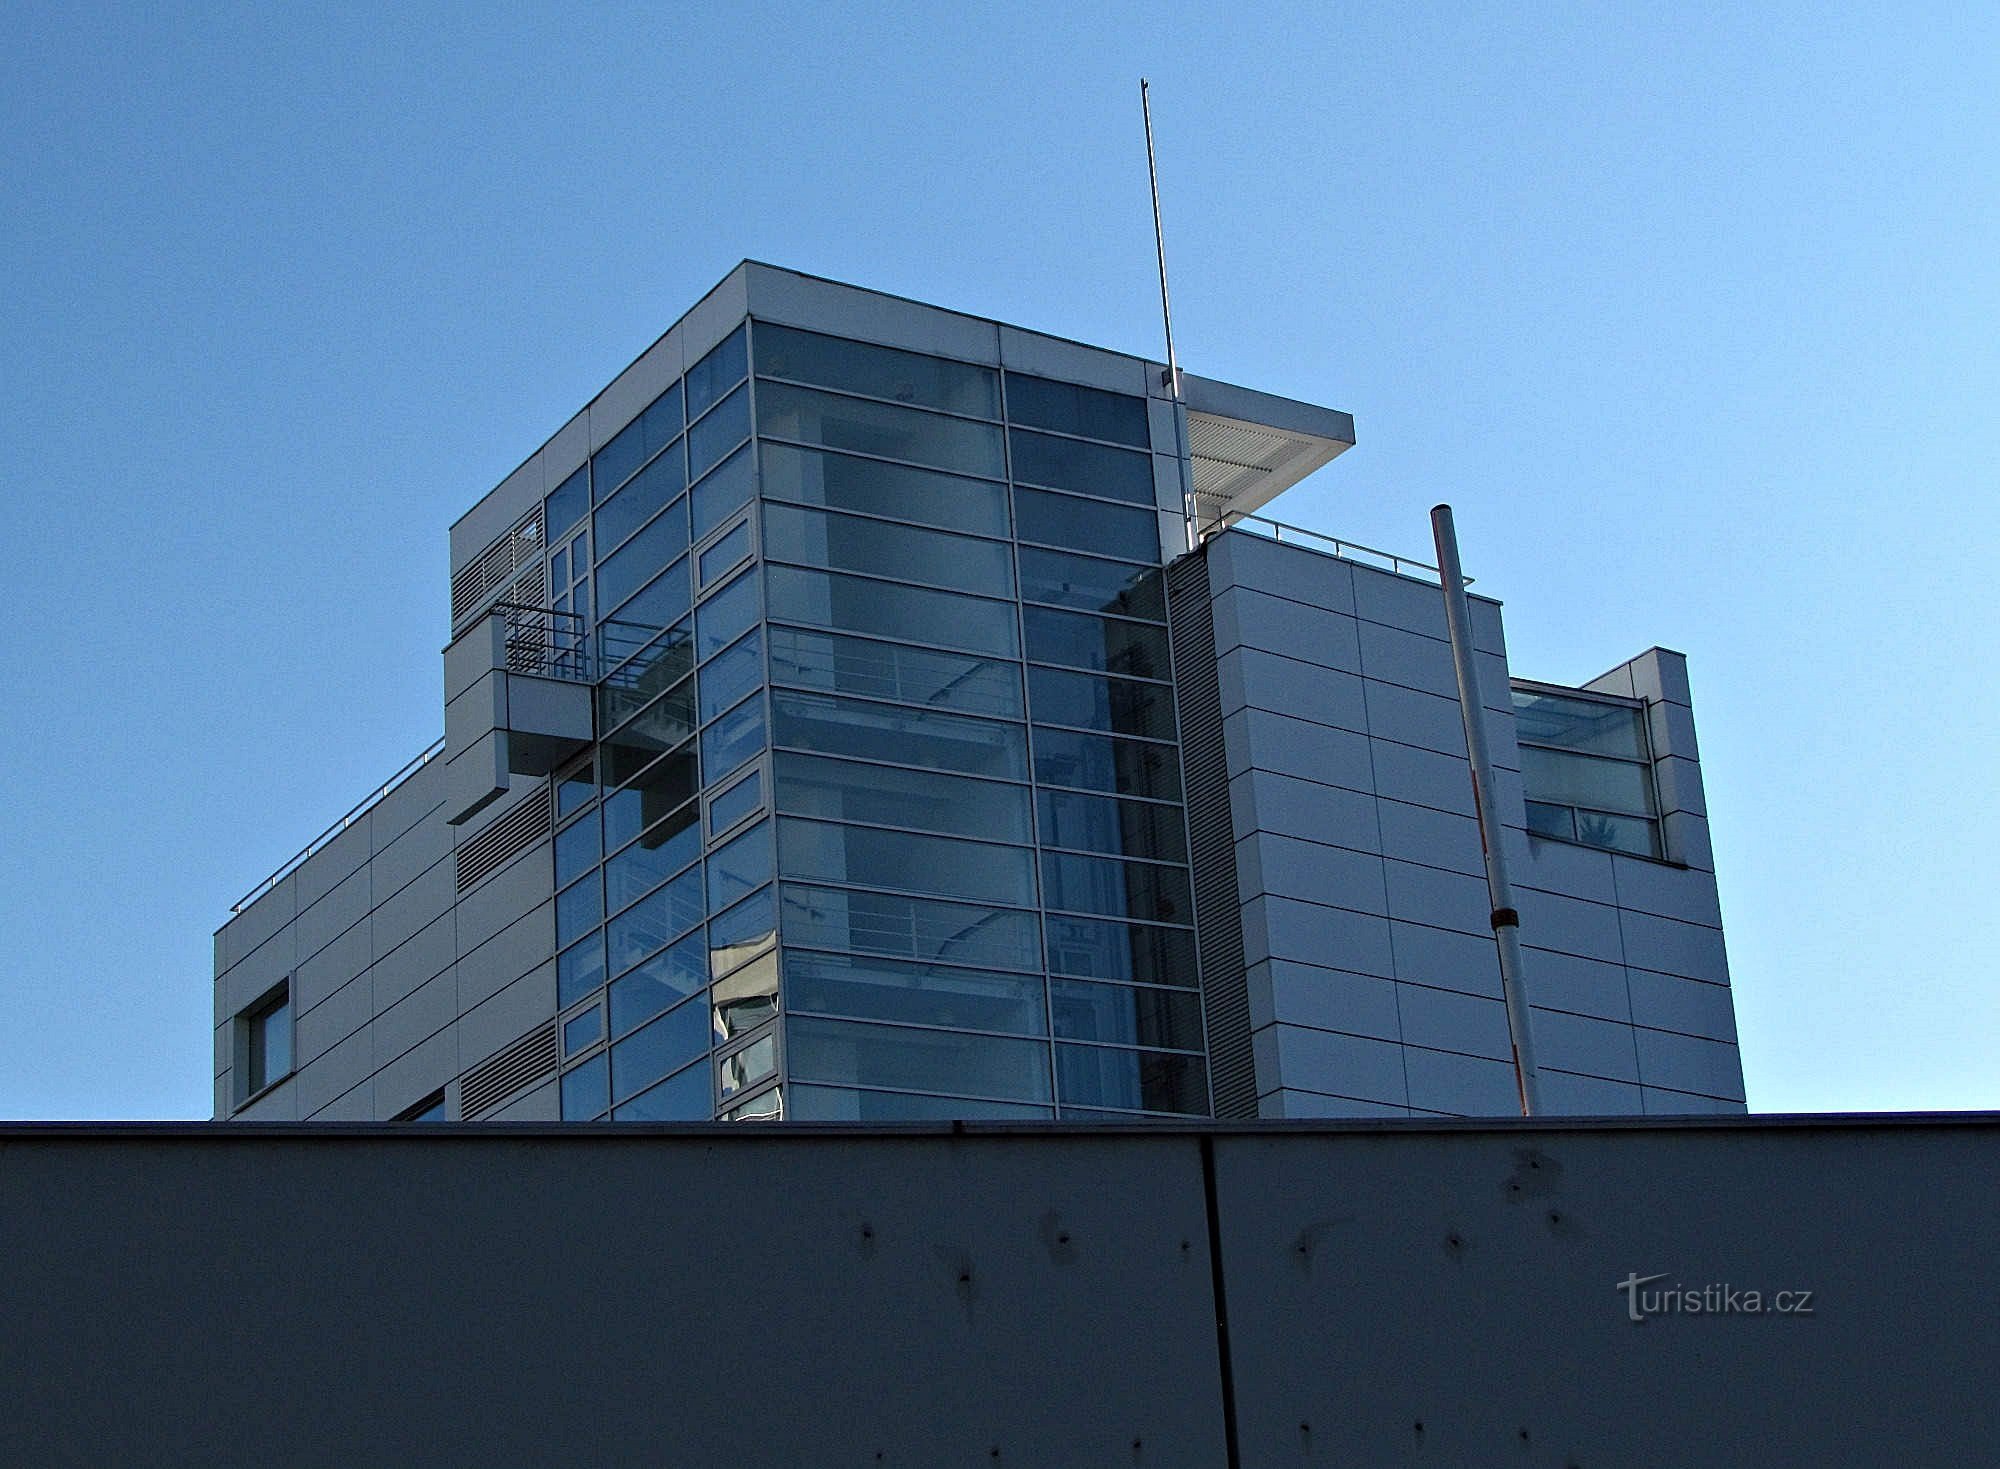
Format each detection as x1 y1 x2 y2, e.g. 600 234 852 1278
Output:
0 2 2000 1117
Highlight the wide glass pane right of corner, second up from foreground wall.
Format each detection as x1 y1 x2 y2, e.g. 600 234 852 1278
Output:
786 1017 1048 1101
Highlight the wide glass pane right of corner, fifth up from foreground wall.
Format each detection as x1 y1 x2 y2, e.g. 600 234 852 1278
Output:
778 817 1034 907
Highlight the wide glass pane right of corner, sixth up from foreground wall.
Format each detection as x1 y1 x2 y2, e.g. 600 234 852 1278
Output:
774 755 1034 843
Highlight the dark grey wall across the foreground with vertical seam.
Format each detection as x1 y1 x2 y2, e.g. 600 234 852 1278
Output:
0 1115 2000 1469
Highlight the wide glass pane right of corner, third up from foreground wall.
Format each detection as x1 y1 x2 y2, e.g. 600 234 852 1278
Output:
784 949 1048 1035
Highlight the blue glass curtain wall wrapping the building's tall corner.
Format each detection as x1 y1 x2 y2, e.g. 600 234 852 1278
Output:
544 322 1210 1121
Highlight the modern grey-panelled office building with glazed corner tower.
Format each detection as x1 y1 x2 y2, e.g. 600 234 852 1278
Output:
214 262 1744 1121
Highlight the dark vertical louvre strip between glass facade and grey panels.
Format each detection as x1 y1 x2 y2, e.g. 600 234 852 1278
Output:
1166 546 1256 1117
